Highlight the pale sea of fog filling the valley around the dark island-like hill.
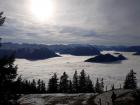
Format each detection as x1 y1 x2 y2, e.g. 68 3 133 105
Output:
15 52 140 88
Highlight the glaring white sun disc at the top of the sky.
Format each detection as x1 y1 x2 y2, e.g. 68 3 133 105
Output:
30 0 54 21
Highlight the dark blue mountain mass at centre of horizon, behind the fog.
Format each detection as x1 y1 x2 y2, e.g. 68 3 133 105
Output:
48 44 100 56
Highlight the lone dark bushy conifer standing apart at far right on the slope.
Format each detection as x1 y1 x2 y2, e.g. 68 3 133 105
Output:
124 69 137 89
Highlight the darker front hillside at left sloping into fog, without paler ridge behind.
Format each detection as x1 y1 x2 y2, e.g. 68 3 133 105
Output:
0 48 58 60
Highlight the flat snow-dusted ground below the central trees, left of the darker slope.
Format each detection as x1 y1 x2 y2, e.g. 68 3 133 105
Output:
19 94 94 105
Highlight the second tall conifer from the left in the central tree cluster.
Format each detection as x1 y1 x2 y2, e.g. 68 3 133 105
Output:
59 72 69 93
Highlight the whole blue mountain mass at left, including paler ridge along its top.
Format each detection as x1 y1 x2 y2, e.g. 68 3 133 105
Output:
0 43 59 60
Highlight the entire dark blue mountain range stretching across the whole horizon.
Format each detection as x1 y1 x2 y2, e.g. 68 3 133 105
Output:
0 42 140 60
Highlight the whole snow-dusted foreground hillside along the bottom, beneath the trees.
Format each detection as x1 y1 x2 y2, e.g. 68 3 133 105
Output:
19 89 135 105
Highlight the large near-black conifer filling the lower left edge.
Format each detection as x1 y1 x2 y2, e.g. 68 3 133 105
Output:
0 55 18 105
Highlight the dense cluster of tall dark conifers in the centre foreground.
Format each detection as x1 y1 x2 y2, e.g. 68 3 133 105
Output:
47 70 104 93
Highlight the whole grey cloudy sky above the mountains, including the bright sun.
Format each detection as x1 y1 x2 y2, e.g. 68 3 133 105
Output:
0 0 140 45
